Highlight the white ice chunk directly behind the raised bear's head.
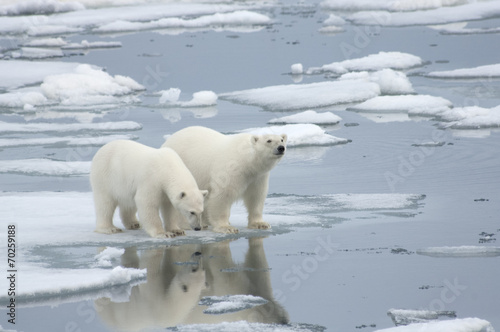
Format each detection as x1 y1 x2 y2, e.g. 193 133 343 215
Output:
241 124 349 147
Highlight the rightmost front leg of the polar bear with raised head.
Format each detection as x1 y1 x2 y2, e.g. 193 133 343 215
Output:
243 174 271 229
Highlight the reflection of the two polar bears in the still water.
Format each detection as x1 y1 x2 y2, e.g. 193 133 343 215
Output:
95 238 288 331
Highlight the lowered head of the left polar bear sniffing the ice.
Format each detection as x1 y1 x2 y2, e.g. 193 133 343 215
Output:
174 190 208 231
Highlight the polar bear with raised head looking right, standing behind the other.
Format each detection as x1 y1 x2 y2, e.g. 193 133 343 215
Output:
162 127 287 233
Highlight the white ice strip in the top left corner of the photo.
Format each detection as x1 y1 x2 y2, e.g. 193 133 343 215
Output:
0 0 85 16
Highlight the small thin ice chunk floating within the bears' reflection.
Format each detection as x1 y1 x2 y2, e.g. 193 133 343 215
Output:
198 295 269 315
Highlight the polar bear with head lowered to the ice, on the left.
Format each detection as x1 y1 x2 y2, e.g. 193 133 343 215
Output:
90 140 208 237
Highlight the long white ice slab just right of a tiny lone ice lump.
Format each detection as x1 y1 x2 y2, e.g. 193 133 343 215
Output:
307 52 423 75
